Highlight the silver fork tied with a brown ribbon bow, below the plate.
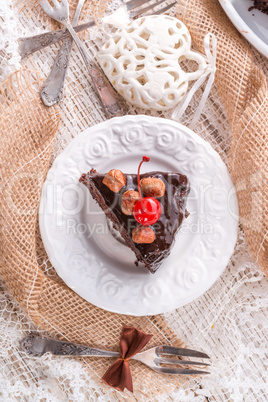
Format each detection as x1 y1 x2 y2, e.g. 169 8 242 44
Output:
20 333 210 375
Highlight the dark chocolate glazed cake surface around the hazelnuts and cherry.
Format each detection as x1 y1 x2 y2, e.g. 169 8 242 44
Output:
79 169 190 272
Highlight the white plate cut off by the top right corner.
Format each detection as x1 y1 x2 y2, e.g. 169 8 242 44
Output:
219 0 268 58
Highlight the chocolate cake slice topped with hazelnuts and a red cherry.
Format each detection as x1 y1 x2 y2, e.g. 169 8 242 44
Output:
79 160 190 273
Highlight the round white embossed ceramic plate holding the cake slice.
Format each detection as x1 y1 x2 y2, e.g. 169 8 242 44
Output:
39 115 238 315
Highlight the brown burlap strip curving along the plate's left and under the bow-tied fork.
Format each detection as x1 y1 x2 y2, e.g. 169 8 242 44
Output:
0 69 188 395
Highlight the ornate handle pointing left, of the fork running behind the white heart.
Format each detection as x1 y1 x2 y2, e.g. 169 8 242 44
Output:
18 21 96 59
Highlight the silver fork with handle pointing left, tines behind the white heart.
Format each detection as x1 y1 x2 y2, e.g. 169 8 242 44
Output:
18 0 177 58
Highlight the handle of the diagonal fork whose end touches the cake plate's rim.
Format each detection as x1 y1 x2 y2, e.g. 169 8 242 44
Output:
64 21 127 119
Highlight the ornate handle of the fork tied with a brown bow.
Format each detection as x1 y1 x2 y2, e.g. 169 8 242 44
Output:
20 333 120 357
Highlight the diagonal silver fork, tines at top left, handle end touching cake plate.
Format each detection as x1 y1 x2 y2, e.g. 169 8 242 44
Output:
39 0 127 119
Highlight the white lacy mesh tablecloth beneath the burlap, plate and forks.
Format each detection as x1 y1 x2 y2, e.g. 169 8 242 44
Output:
0 0 268 402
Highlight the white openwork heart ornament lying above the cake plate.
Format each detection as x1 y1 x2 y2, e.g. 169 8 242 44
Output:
98 15 215 117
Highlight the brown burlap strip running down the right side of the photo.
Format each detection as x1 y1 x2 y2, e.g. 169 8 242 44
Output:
178 0 268 275
